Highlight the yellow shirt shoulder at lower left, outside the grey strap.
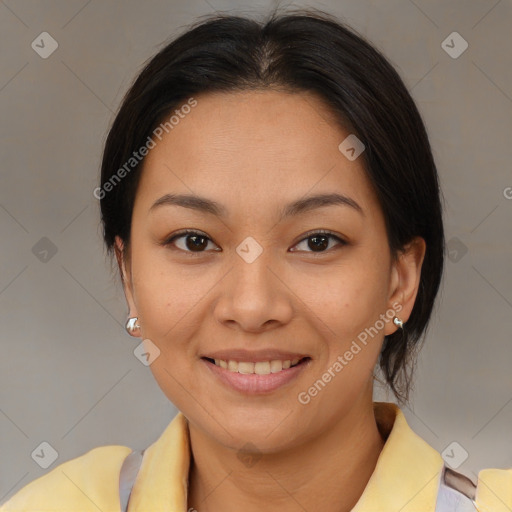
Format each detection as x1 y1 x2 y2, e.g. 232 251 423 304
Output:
0 445 132 512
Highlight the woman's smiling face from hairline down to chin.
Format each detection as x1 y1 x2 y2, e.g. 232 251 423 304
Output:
118 91 424 452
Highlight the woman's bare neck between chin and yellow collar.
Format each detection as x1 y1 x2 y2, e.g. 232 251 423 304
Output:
188 395 384 512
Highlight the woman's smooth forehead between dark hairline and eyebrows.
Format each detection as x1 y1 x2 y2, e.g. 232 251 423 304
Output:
137 90 375 218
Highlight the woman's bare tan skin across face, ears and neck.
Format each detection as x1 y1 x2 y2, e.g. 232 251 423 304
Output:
116 90 425 512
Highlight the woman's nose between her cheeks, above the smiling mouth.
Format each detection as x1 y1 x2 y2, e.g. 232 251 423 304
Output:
214 251 294 333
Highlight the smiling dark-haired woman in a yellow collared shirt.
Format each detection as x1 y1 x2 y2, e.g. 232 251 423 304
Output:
0 11 512 512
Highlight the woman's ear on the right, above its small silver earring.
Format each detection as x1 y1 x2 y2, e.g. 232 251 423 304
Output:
384 236 427 336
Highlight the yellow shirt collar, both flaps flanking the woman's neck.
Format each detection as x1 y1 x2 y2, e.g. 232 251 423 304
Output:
130 402 443 512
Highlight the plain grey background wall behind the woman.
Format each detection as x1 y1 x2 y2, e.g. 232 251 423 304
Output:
0 0 512 502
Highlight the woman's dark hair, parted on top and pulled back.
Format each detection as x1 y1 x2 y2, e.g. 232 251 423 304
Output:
100 5 445 403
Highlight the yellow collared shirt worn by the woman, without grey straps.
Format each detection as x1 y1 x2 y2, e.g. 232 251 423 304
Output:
0 402 512 512
